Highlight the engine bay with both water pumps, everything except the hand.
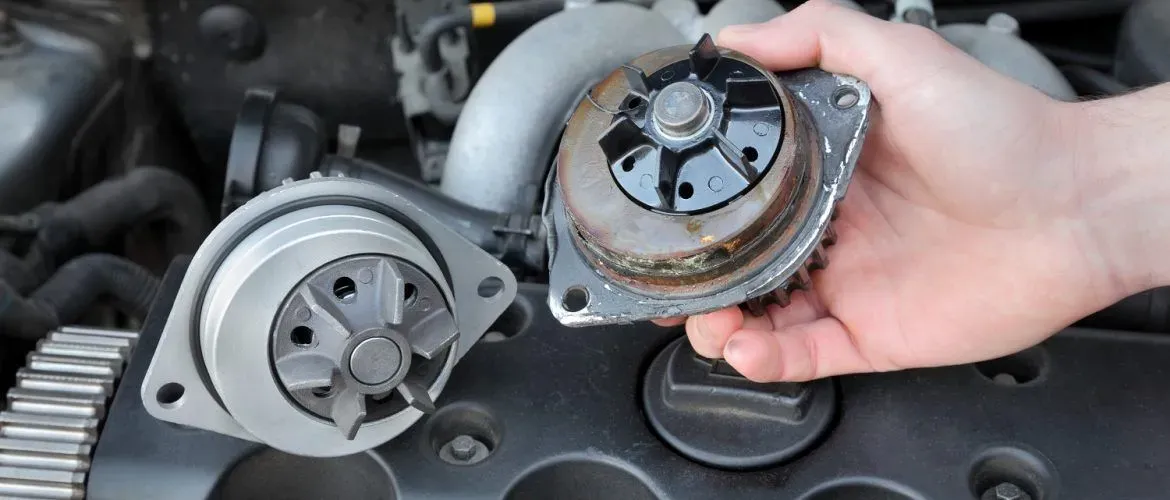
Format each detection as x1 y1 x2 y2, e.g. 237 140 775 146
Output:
0 0 1170 500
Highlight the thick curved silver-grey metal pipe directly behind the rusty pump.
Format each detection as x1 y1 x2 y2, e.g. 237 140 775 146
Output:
440 4 687 213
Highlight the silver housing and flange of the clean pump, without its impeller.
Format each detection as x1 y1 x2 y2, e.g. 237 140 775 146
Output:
142 176 516 457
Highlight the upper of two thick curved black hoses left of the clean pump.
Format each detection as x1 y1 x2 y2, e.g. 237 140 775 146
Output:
25 167 211 279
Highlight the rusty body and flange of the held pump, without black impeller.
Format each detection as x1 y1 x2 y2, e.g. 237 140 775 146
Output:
544 42 870 326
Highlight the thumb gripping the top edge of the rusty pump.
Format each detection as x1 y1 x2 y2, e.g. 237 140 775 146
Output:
718 0 940 89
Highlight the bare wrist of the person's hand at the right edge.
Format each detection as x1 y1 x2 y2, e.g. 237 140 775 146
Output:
1062 85 1170 300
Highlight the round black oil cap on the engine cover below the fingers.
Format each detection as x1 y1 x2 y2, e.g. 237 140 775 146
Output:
642 338 837 470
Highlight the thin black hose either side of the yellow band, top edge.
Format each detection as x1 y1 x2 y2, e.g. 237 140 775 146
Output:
415 0 565 73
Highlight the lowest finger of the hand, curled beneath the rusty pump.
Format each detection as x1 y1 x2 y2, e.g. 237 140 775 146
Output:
723 317 873 382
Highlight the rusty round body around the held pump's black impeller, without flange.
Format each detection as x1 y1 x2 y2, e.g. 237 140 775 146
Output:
557 46 804 292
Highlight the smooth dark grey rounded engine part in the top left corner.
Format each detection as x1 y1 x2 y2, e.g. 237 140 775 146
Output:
0 5 121 213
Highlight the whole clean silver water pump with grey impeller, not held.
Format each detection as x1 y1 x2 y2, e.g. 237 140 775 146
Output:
142 174 516 456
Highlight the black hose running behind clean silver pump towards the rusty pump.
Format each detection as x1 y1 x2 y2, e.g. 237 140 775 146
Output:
321 156 548 273
